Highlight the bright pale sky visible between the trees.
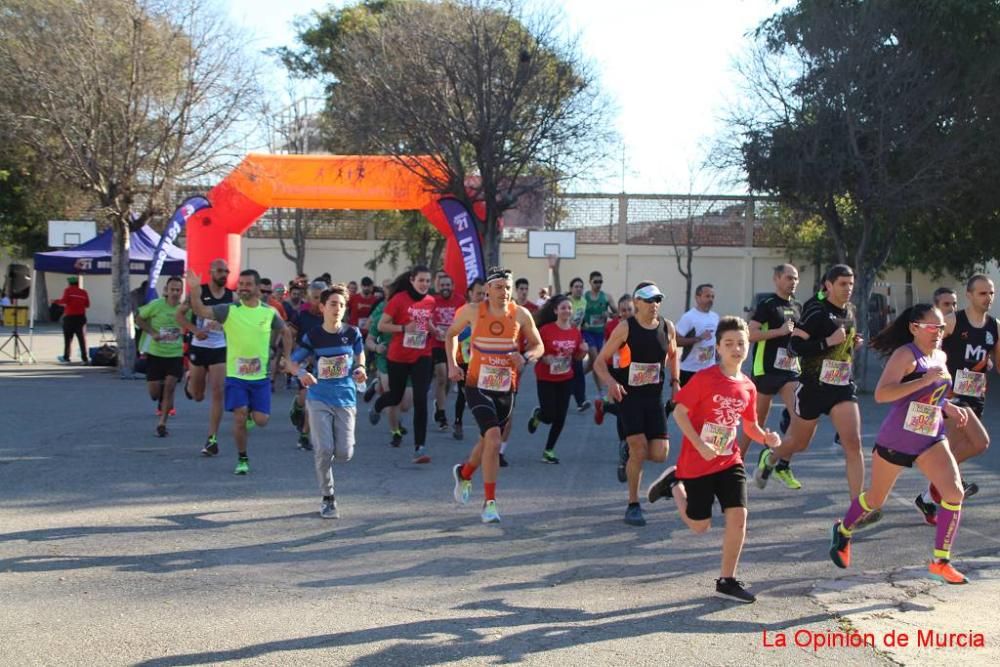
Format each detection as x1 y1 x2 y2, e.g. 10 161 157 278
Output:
228 0 790 193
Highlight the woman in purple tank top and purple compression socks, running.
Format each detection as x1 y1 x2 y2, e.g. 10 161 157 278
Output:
830 304 969 584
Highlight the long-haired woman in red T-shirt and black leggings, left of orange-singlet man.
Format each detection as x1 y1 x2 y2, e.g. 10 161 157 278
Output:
368 266 434 463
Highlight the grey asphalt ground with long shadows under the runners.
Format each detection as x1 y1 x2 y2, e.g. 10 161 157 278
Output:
0 332 1000 665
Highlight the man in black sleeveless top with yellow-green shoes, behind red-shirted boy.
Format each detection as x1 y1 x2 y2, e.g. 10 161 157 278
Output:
739 264 802 489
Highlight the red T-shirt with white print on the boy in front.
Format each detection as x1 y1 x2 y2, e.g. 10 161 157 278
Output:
674 365 757 479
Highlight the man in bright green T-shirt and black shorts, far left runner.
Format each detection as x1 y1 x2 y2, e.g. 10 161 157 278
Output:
136 276 184 438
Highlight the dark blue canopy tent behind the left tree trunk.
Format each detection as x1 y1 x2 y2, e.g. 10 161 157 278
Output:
30 225 187 332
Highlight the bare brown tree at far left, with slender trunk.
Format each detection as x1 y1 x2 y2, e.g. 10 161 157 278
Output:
0 0 257 376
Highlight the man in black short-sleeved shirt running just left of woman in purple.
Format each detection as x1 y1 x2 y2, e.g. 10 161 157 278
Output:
754 264 868 504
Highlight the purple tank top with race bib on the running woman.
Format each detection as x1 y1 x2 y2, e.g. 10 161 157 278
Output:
875 343 949 454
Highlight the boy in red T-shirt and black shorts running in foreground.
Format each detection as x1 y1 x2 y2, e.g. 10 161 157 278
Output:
647 316 781 602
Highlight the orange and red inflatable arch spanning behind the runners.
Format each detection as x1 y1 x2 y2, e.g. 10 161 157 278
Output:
187 153 484 294
